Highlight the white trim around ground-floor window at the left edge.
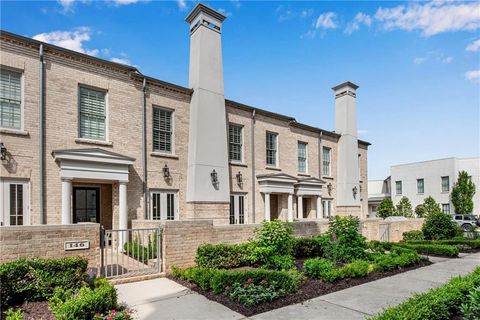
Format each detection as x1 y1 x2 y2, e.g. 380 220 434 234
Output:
0 179 31 226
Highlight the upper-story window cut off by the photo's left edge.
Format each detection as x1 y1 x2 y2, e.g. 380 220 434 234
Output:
0 69 22 129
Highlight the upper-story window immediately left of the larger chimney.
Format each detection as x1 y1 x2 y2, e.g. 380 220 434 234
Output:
152 107 173 153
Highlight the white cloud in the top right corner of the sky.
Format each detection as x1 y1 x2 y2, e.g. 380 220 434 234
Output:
375 0 480 37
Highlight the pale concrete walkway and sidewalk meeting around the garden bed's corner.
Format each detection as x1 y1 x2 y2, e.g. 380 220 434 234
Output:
116 253 480 320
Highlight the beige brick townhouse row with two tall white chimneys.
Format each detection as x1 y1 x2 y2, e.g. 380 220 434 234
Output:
0 4 369 229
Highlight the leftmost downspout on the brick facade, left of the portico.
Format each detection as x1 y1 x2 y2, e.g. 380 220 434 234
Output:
38 44 46 224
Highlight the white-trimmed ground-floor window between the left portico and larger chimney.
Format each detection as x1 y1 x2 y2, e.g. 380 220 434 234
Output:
150 191 178 220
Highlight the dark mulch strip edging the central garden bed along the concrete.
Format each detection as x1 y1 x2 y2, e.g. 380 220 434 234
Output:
170 259 432 317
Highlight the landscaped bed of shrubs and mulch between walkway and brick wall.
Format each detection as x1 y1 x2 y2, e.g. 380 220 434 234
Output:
170 217 430 316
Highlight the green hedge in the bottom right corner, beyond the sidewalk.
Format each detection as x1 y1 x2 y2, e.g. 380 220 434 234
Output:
370 267 480 320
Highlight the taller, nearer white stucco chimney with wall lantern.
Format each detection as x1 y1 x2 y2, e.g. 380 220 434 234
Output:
186 3 230 202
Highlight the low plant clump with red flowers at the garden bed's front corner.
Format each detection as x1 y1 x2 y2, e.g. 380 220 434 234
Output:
224 279 285 308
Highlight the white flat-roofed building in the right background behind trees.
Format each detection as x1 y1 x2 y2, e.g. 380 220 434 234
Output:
368 158 480 216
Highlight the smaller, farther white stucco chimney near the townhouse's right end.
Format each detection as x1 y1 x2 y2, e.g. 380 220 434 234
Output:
332 81 360 207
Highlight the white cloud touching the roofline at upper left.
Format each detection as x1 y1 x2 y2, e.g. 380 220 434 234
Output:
33 27 99 56
